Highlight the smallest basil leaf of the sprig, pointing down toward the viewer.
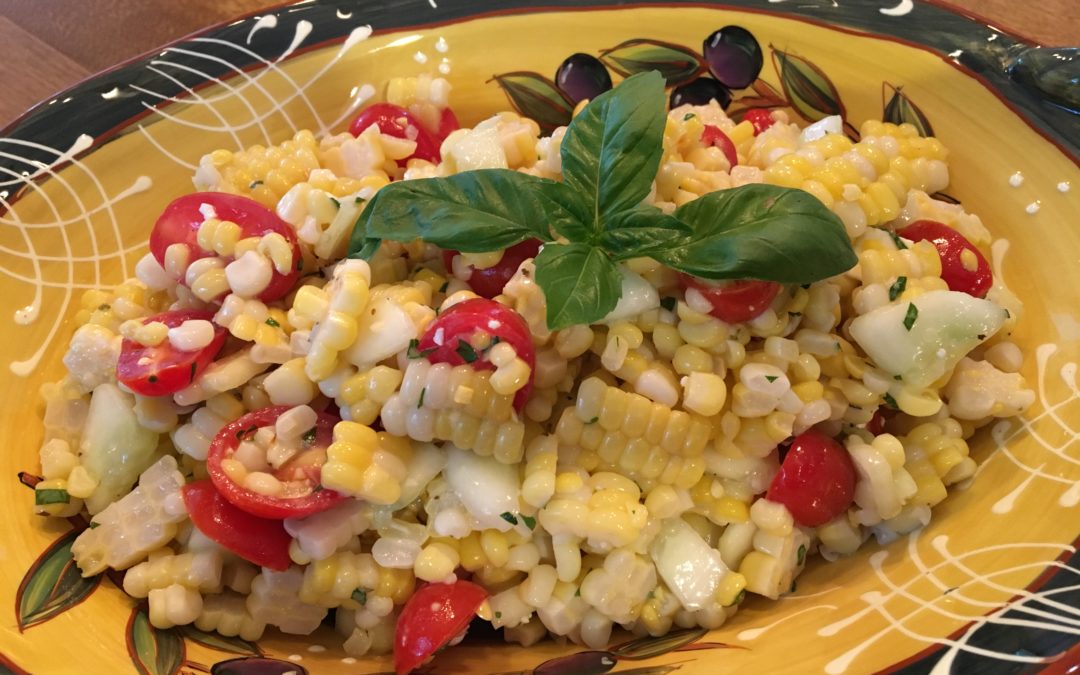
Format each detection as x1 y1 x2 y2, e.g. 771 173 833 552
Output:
536 242 622 330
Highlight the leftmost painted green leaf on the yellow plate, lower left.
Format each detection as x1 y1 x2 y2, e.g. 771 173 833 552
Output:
15 530 102 631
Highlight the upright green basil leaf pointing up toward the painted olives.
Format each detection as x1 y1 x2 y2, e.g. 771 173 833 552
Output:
562 71 666 234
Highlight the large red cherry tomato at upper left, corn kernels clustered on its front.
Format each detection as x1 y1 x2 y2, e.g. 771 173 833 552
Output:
150 192 301 301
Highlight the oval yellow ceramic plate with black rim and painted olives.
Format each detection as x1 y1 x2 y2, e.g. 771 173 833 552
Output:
0 0 1080 675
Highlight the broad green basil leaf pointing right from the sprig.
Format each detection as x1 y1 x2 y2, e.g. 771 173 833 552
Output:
654 185 858 283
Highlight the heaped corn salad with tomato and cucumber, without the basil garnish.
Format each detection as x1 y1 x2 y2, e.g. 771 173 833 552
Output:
37 71 1034 656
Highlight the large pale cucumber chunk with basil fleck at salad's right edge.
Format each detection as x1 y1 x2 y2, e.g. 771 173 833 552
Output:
851 291 1008 388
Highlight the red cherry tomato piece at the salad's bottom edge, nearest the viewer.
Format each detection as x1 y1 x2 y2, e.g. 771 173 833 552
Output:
394 580 487 675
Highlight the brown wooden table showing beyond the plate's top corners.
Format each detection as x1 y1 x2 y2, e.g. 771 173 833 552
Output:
0 0 1080 127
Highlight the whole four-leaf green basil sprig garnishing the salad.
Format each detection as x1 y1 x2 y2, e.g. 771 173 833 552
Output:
349 72 856 330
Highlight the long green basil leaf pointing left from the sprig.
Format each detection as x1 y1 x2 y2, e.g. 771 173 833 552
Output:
349 168 570 253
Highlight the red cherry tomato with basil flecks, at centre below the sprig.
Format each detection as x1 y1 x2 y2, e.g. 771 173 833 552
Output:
417 298 537 410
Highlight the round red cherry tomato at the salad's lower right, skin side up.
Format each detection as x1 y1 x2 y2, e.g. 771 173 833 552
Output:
766 429 855 527
